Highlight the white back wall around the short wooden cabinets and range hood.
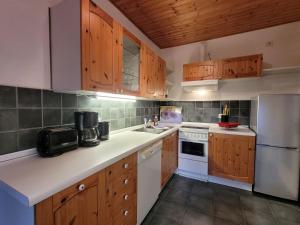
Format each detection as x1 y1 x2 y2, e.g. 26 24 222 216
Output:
162 22 300 100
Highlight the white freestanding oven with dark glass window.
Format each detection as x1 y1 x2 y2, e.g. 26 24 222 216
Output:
178 126 208 181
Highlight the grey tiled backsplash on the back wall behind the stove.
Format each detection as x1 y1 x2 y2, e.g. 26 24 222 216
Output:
161 101 250 125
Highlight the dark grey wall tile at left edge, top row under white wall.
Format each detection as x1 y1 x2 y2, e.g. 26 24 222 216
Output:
0 86 17 108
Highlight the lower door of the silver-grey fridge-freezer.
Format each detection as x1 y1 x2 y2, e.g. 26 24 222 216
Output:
254 145 300 200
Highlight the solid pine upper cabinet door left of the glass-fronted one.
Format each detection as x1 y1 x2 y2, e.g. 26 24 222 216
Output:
82 0 115 92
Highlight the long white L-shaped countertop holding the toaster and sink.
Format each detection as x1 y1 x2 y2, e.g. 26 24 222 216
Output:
0 123 255 207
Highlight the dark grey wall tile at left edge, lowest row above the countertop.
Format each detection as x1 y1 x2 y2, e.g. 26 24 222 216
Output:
0 132 18 155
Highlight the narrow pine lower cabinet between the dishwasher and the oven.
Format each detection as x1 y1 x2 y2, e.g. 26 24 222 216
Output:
161 132 178 187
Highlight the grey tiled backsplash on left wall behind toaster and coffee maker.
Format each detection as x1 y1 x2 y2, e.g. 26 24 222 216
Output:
0 86 159 155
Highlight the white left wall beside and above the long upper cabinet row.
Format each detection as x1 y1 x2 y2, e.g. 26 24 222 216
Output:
0 0 160 89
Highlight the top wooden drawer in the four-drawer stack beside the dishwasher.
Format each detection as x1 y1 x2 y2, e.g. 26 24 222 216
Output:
105 154 137 182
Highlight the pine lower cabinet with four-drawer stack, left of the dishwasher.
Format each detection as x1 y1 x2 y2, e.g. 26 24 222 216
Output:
35 154 137 225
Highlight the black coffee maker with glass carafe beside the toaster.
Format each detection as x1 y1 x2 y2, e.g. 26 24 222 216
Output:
74 112 100 147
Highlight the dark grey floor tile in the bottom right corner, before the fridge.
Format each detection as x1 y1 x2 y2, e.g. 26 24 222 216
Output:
271 202 300 223
